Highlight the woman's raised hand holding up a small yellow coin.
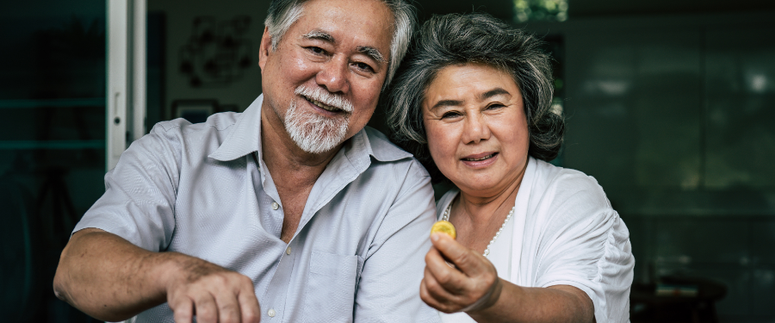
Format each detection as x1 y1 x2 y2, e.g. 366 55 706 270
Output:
420 233 503 313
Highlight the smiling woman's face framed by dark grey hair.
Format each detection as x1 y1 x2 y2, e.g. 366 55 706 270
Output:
422 63 529 197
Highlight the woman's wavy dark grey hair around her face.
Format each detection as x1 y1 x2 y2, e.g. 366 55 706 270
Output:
386 13 565 181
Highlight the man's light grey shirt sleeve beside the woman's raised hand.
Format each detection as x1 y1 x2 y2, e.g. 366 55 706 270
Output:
354 160 440 322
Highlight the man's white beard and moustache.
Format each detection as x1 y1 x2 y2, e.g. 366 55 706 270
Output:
283 87 352 154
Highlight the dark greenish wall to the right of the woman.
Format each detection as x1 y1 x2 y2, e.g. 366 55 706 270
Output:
527 13 775 322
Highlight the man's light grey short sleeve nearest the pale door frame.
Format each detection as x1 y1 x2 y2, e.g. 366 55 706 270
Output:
73 122 181 251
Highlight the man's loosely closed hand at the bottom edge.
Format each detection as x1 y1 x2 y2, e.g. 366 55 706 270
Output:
167 258 261 323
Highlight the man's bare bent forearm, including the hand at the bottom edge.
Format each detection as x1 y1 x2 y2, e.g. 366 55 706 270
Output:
54 228 261 323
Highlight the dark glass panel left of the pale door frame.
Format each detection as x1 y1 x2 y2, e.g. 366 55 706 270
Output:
0 0 106 322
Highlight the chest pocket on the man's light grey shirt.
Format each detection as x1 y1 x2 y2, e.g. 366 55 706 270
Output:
303 251 363 322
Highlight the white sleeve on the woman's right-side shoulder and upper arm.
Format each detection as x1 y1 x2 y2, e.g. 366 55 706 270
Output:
536 175 634 322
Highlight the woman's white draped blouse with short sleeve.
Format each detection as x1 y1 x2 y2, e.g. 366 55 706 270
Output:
436 157 635 323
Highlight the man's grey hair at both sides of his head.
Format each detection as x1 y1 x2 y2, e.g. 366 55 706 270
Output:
264 0 416 90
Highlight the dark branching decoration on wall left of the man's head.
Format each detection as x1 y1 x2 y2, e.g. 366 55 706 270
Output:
178 16 255 88
